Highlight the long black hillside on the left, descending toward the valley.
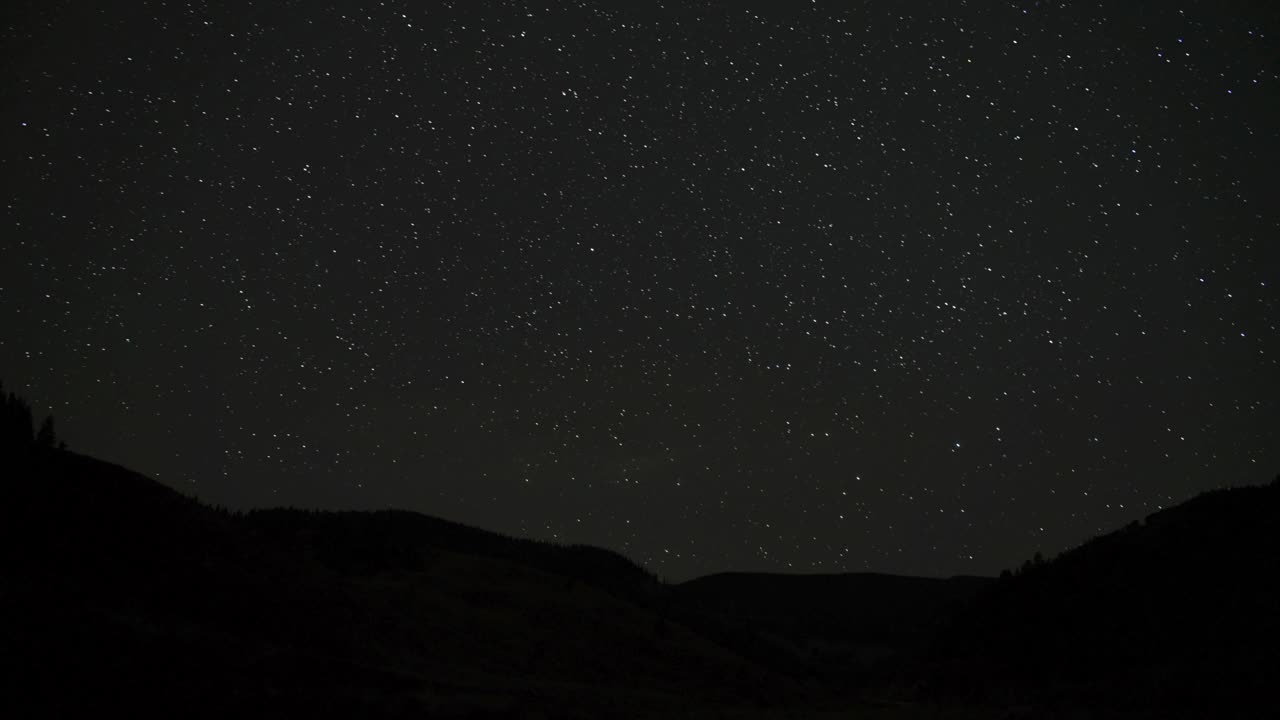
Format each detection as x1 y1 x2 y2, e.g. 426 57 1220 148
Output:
0 448 803 717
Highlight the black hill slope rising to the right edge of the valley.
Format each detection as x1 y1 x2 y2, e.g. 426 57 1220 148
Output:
922 482 1280 717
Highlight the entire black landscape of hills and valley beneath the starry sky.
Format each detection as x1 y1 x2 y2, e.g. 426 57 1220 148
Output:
0 384 1280 719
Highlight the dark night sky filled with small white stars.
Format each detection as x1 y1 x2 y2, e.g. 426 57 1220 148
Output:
0 0 1280 579
